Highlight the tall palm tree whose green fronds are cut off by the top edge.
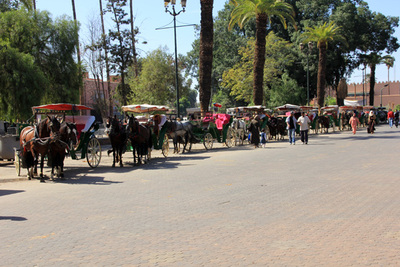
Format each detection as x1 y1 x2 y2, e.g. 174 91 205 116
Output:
229 0 295 105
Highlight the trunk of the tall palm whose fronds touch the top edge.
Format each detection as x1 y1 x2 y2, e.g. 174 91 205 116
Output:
253 13 268 105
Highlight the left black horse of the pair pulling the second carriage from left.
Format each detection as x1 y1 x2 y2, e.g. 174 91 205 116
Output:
106 116 127 168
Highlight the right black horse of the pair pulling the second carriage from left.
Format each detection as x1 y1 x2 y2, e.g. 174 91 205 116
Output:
126 115 153 165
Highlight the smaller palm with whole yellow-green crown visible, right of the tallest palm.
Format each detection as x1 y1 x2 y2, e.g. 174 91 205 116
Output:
303 22 346 107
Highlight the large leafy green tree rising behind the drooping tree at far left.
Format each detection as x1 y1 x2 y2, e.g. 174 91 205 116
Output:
0 9 82 111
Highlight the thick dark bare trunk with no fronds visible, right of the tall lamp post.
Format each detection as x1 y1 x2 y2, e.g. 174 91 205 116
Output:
199 0 214 115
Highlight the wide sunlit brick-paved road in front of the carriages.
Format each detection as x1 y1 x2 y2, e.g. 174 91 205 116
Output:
0 125 400 266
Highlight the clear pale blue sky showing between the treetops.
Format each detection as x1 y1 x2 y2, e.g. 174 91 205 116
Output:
36 0 400 85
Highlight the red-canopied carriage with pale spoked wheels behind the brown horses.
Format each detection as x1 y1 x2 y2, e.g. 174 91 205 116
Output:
15 103 101 181
